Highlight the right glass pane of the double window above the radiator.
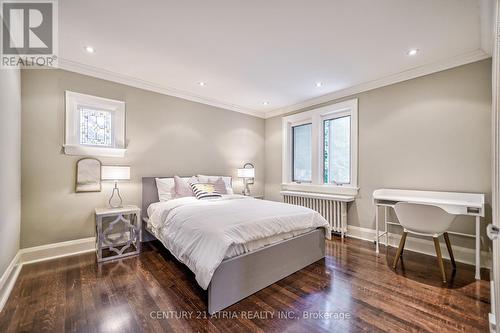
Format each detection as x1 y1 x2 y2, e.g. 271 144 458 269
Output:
323 116 351 185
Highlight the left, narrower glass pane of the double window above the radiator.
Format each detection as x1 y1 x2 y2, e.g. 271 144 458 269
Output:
292 124 312 183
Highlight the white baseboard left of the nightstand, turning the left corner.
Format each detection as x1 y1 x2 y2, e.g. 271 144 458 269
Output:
0 237 95 311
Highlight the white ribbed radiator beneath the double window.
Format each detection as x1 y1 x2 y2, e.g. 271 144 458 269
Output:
281 191 347 237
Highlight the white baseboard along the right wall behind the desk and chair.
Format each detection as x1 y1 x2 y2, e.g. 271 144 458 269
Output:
347 226 492 268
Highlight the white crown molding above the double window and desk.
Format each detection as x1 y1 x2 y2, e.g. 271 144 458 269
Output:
265 49 491 119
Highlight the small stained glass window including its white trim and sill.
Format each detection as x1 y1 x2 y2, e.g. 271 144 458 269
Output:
64 91 125 157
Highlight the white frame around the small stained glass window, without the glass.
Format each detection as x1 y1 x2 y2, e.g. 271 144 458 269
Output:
63 90 127 157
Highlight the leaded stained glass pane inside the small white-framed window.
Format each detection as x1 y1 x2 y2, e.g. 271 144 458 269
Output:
79 106 113 147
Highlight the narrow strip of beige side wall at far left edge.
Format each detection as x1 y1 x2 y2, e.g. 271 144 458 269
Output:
0 69 21 274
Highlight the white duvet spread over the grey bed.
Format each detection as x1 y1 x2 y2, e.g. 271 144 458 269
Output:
148 195 330 289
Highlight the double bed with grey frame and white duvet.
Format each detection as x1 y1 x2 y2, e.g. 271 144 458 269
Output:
142 177 330 314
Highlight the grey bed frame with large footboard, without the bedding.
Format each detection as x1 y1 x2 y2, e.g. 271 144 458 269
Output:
142 177 325 314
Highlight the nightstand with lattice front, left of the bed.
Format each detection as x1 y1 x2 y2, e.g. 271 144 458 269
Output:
95 206 142 262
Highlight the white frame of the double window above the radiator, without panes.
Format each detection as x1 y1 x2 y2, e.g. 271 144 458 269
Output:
281 98 359 195
